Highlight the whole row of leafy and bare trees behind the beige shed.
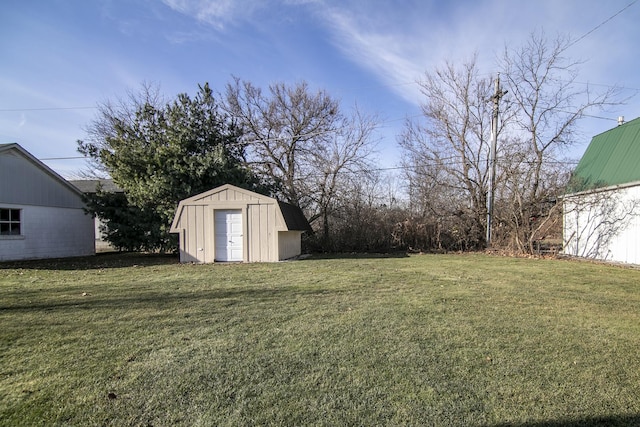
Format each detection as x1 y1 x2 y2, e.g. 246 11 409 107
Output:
78 33 620 253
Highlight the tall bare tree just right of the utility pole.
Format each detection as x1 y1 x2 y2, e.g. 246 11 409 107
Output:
499 33 619 252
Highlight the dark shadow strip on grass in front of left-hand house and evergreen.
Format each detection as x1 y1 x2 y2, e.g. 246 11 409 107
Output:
0 252 179 270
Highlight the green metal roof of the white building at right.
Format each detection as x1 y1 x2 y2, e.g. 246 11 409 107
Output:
568 118 640 193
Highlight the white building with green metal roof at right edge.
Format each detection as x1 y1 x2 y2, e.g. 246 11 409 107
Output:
563 118 640 264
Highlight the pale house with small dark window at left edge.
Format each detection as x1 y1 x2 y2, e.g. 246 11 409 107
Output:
0 144 95 261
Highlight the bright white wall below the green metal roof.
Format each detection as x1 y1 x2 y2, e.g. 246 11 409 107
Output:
563 185 640 264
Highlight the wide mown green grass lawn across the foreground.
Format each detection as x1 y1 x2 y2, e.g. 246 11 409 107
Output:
0 254 640 426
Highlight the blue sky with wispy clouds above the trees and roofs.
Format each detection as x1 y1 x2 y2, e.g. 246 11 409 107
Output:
0 0 640 177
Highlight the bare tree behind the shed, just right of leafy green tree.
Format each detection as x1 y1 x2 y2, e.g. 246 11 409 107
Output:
225 78 342 208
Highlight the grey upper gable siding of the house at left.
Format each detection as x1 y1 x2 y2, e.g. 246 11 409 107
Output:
0 150 84 209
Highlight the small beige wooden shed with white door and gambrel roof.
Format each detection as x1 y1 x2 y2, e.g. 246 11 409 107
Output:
170 184 310 263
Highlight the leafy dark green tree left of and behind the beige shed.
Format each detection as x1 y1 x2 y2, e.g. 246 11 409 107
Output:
78 84 268 251
